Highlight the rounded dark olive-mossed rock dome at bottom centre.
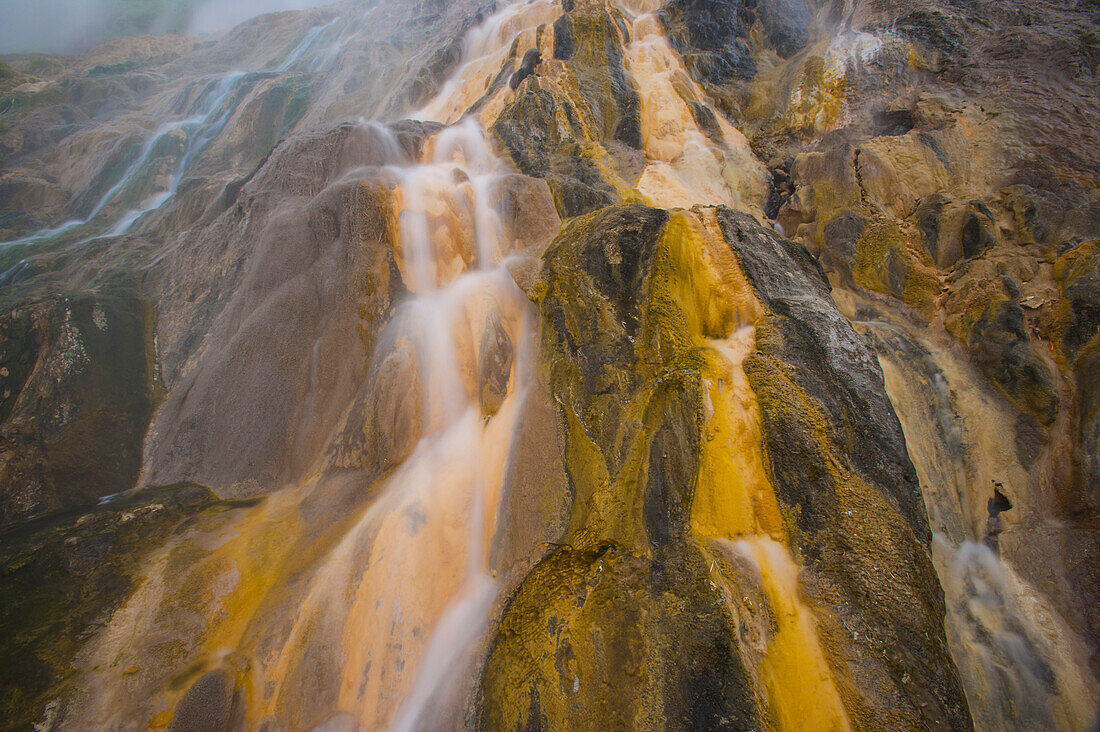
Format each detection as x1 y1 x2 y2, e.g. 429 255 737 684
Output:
477 544 765 730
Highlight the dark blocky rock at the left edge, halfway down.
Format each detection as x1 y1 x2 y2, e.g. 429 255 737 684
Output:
0 293 155 524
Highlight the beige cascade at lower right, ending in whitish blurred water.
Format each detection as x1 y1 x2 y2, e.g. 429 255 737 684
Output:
856 320 1093 730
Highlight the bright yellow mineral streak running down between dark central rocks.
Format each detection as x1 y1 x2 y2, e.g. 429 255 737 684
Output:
667 209 849 730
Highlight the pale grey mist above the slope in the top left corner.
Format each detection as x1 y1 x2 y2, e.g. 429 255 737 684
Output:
0 0 334 54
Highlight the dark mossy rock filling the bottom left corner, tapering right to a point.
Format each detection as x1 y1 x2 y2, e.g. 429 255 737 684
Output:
0 485 226 729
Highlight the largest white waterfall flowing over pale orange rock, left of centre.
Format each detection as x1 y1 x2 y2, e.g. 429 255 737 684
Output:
247 120 532 730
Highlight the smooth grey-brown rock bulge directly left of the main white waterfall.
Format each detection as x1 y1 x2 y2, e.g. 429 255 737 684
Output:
146 135 411 491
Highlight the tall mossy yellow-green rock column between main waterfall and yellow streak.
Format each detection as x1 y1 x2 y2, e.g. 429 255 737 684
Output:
480 206 762 729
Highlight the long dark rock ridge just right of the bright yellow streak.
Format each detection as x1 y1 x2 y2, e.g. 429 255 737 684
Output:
718 209 969 726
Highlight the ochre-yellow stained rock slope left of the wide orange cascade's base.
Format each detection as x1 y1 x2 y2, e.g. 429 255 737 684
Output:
77 491 303 729
